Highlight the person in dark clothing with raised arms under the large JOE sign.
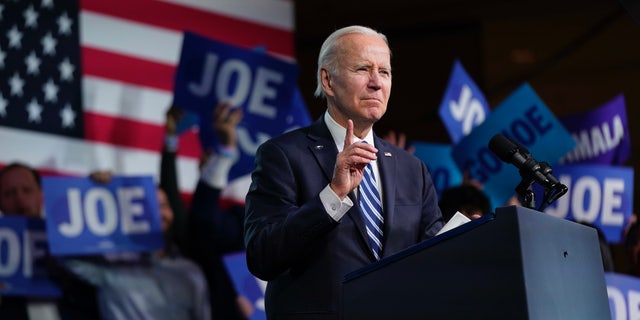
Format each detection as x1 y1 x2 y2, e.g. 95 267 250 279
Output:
160 102 253 320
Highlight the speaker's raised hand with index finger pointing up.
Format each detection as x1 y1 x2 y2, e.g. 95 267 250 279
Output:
330 120 378 199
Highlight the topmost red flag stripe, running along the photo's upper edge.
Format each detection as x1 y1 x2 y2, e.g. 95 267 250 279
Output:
81 0 295 57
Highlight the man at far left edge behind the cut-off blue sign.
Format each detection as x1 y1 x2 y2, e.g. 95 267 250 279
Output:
0 161 98 320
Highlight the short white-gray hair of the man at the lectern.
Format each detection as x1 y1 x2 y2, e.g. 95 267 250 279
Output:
314 26 389 99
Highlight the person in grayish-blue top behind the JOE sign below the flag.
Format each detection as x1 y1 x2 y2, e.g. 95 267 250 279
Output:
64 171 211 320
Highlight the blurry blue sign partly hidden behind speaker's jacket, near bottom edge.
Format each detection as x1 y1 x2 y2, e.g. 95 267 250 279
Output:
223 252 267 320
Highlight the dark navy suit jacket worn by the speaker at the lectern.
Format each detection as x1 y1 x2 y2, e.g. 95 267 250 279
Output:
245 118 444 319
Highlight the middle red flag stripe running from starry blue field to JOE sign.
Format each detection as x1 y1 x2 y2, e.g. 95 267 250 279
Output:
82 46 176 92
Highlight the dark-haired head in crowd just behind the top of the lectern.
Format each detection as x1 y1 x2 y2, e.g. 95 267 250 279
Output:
439 183 491 221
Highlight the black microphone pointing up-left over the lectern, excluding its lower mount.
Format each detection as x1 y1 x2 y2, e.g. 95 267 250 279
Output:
489 134 567 193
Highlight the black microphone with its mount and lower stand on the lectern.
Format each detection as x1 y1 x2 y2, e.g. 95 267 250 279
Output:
489 134 568 211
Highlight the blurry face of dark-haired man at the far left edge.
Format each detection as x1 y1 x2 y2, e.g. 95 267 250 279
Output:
0 167 44 217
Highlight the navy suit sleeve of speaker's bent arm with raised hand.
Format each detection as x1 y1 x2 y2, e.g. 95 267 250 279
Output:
244 141 337 281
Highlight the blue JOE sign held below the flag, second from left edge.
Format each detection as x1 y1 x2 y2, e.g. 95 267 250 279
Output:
42 176 163 255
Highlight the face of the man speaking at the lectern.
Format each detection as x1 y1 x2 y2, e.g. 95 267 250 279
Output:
325 34 391 125
